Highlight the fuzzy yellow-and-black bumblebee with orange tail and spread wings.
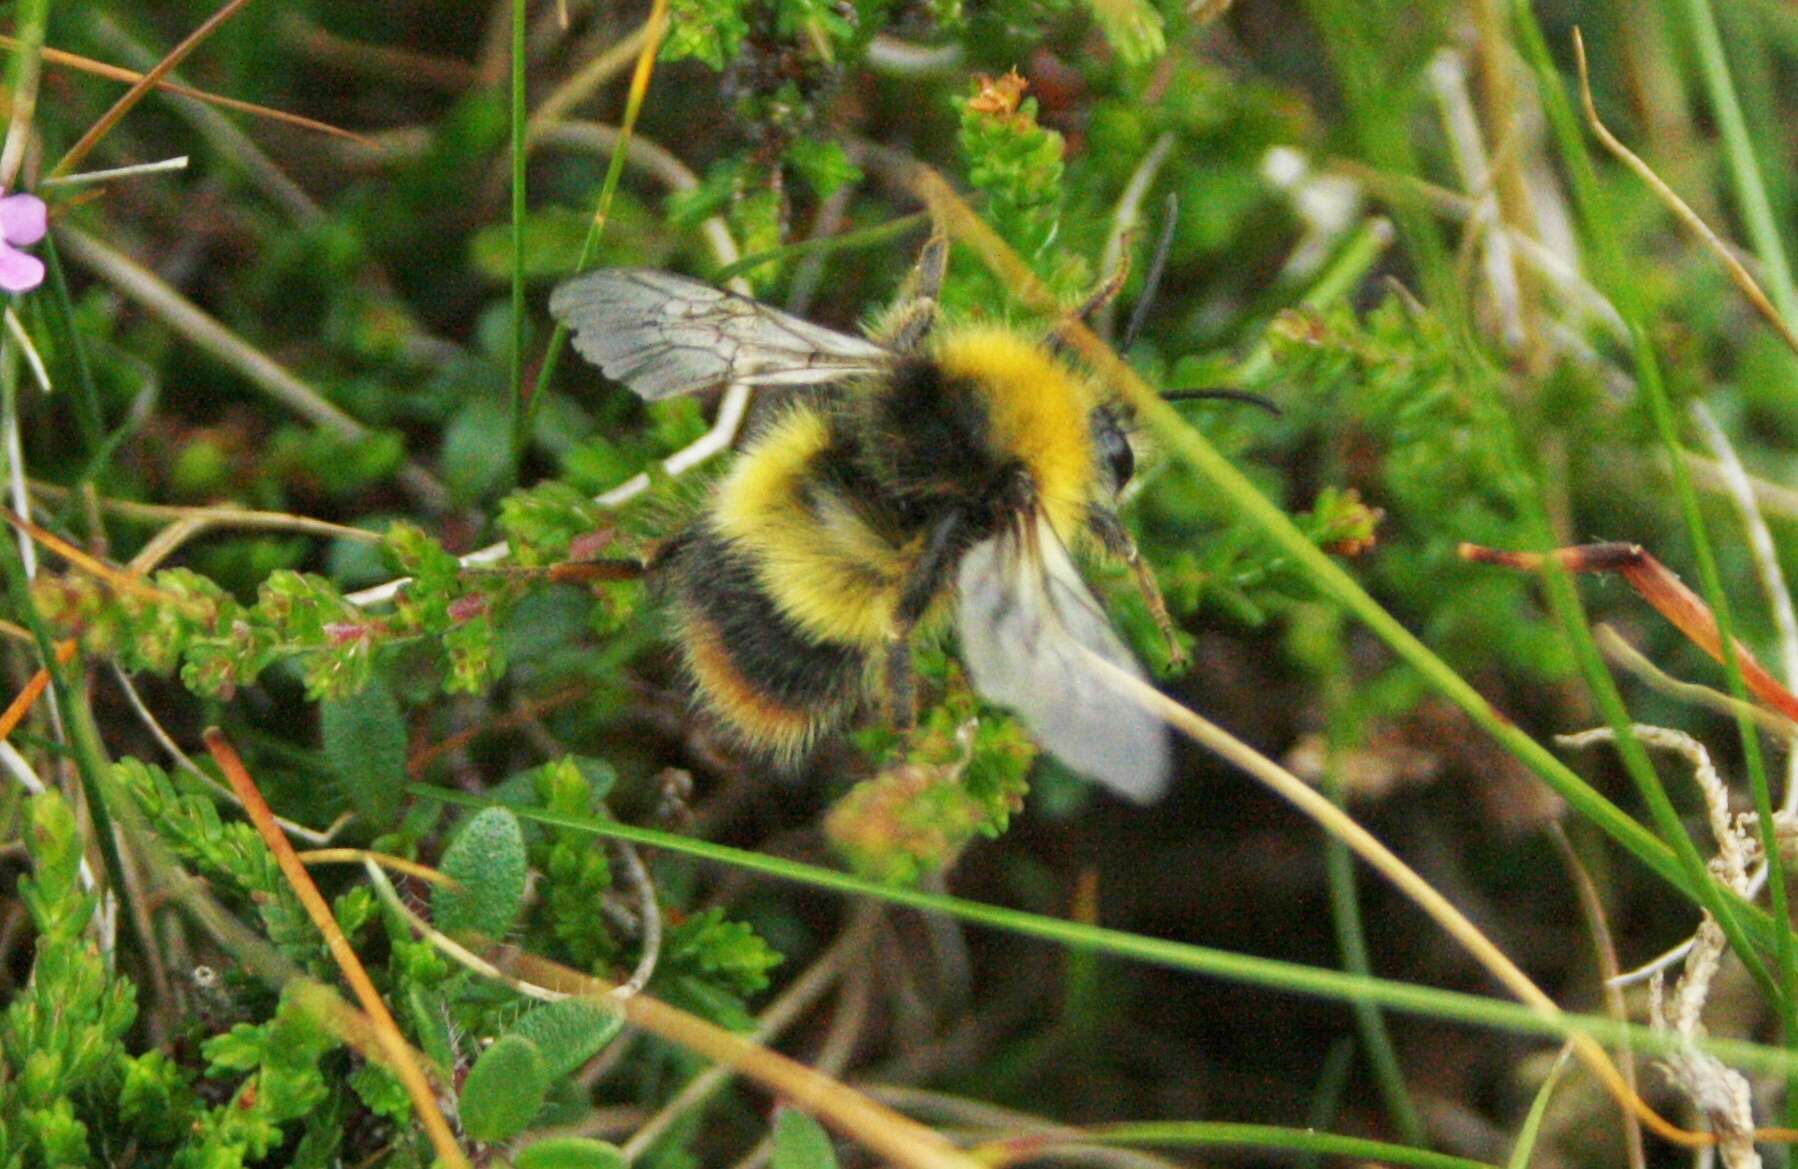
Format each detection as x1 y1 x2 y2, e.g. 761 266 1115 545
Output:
550 236 1172 802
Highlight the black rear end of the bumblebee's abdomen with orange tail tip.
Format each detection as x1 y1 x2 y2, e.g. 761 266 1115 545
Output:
653 520 867 764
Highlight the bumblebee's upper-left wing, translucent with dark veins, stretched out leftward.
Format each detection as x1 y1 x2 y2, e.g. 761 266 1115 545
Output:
550 268 892 401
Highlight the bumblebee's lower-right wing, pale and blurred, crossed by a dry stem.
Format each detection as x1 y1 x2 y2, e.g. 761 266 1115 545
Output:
957 516 1169 804
